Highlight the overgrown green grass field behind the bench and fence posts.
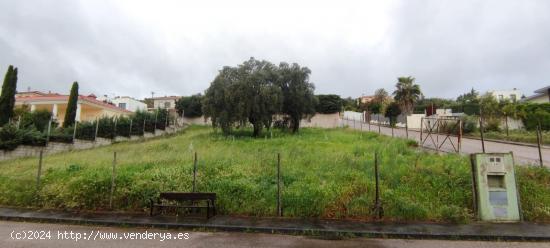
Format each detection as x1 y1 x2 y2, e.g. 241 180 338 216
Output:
0 126 550 222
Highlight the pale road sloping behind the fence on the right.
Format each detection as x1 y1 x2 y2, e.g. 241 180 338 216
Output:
342 120 550 167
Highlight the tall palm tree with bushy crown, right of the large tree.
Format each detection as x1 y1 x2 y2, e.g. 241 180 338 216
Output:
393 76 422 115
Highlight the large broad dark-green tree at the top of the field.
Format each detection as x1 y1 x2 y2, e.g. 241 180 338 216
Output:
203 58 316 136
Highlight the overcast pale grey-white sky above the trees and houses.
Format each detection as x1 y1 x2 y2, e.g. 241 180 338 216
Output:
0 0 550 98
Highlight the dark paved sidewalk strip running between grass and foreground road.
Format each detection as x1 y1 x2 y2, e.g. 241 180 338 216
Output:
0 208 550 241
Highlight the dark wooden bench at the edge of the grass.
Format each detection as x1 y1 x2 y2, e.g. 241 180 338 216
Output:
150 192 216 219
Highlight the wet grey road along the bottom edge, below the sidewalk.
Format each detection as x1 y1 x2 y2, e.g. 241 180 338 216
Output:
0 221 550 248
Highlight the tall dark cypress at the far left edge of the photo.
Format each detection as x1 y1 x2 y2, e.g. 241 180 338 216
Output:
0 65 17 126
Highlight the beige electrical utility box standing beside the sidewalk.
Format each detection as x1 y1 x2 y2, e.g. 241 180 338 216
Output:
471 153 521 222
